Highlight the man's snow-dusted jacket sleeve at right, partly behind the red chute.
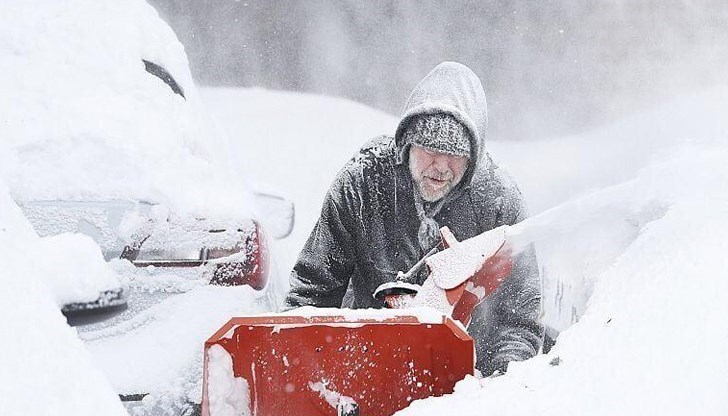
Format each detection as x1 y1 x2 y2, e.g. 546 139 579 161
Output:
474 187 543 375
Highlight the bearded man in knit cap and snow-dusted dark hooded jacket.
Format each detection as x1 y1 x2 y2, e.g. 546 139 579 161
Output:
286 62 543 375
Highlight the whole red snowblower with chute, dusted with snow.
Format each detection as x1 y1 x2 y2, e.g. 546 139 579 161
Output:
202 226 512 416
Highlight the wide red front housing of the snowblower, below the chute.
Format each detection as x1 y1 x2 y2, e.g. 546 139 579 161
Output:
202 309 474 416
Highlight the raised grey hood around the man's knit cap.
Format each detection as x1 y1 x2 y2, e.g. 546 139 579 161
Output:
394 62 488 184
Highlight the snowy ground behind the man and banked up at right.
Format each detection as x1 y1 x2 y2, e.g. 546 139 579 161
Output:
203 84 728 415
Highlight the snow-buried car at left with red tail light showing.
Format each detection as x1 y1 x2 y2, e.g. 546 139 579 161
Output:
0 0 293 414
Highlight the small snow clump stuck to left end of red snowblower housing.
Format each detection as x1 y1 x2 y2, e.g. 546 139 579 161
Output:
207 344 251 416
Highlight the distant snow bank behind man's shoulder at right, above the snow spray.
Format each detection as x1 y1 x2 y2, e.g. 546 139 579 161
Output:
486 86 728 214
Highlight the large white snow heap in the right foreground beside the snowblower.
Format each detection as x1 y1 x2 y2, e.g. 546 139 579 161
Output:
399 90 728 416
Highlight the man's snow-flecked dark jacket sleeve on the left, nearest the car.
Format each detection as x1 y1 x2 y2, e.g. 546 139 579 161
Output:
286 170 357 307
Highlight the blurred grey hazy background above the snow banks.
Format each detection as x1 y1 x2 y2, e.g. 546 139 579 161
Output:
150 0 728 141
